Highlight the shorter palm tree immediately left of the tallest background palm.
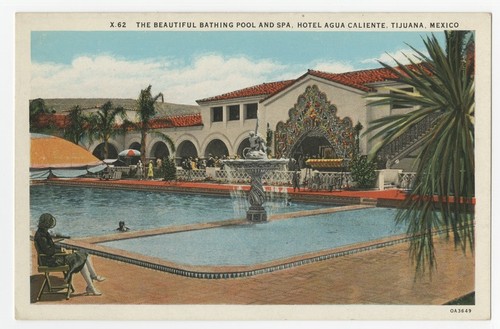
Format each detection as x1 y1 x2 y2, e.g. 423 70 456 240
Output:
89 101 125 159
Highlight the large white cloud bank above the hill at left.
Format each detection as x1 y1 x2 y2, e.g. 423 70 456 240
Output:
31 54 287 104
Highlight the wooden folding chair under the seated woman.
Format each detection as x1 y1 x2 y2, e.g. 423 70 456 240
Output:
35 243 75 301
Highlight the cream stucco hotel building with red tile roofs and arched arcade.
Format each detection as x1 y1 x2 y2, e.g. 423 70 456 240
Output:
31 68 426 170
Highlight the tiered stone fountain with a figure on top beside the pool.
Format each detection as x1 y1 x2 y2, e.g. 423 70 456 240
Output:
224 122 288 222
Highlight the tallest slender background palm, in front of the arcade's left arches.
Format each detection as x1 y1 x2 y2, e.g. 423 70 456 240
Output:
135 85 175 163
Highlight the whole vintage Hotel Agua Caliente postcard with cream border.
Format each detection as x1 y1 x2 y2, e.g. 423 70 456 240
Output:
15 12 491 320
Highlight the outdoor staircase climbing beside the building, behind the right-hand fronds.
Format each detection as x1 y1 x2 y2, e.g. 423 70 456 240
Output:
378 113 441 169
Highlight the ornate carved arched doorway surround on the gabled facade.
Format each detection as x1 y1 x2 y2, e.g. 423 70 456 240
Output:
275 85 355 159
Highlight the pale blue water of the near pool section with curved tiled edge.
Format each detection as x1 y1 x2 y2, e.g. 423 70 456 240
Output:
101 208 406 266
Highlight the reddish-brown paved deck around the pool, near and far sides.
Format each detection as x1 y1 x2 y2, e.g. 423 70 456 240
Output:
31 180 475 310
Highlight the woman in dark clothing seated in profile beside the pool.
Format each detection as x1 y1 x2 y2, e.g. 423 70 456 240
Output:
34 213 105 296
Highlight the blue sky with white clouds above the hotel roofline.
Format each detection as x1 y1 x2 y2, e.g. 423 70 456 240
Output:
30 31 442 104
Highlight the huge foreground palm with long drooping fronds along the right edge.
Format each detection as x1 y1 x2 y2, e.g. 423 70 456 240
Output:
367 31 475 273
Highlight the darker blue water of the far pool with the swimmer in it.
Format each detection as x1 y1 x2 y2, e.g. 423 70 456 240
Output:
30 185 331 238
